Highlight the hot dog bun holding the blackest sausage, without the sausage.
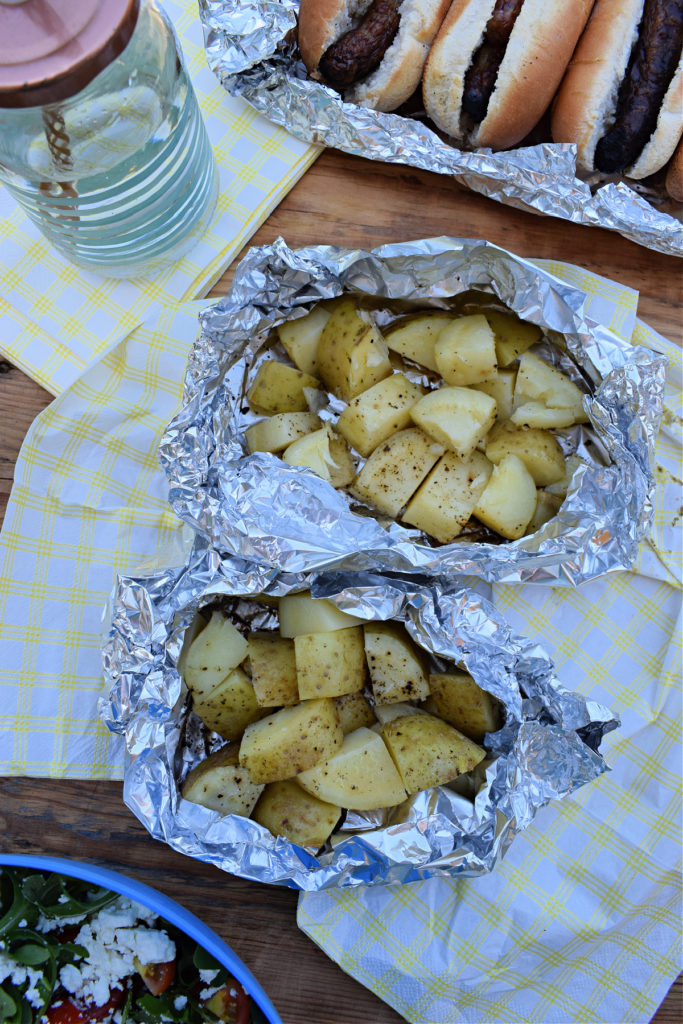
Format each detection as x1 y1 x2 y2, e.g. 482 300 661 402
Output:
551 0 683 179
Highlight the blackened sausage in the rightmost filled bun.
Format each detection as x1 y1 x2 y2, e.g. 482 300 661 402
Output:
594 0 683 174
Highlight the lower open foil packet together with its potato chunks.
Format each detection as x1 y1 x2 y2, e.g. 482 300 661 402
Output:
100 538 618 891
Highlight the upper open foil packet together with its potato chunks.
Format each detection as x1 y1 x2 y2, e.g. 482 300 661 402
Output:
161 238 666 585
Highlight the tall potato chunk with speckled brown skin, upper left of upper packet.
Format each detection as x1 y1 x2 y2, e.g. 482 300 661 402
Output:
317 299 391 401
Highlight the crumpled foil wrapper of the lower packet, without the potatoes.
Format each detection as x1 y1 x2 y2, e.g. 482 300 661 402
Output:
99 538 620 891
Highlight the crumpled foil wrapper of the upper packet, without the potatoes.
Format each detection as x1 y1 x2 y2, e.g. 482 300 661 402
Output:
160 238 667 585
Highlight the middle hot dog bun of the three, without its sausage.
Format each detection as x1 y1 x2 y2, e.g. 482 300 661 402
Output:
423 0 593 150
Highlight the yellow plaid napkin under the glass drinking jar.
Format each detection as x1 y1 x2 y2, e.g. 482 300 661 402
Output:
0 0 321 394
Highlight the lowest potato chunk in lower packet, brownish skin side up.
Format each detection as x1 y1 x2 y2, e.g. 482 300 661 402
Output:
252 779 342 850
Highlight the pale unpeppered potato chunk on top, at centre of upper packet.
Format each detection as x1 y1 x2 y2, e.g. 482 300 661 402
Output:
411 387 496 459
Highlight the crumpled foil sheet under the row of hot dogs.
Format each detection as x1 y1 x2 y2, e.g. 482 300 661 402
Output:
200 0 683 256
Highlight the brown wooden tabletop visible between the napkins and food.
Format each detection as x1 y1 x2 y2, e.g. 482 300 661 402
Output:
0 152 683 1024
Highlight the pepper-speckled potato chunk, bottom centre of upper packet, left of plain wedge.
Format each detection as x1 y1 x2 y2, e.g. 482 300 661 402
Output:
402 452 492 544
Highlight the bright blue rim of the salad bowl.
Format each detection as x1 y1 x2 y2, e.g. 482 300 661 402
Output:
0 853 283 1024
